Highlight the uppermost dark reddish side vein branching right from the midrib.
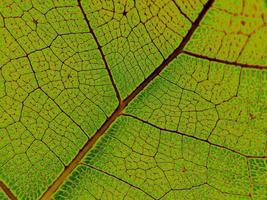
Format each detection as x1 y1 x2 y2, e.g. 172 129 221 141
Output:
182 50 267 70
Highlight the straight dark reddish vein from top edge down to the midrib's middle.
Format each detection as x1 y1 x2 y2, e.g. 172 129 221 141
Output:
78 0 121 102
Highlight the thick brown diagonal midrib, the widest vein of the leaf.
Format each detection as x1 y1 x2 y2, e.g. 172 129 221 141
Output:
41 0 214 200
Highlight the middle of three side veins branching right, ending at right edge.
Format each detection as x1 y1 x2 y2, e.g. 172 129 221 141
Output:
123 114 267 158
